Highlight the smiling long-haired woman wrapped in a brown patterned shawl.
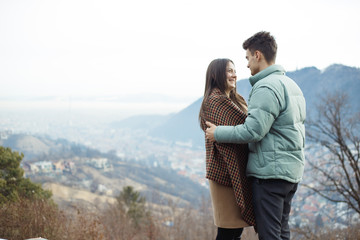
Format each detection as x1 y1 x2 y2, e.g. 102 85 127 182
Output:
199 59 255 240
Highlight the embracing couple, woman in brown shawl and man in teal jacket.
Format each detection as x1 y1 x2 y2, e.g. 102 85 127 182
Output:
199 32 306 240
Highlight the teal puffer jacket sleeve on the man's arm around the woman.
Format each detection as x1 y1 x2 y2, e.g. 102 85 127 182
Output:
214 86 280 143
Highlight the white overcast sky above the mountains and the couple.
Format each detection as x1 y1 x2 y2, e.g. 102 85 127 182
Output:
0 0 360 99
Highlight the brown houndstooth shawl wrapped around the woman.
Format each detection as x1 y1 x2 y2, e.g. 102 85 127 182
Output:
201 89 255 226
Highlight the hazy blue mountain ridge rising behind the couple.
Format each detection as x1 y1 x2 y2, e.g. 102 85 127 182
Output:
150 64 360 148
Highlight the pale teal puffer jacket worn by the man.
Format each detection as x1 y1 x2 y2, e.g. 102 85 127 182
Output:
215 65 306 183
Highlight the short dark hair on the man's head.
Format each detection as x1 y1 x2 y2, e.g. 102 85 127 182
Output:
243 31 277 63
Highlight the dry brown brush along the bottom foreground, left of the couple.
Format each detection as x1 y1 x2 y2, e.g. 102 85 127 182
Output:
0 196 257 240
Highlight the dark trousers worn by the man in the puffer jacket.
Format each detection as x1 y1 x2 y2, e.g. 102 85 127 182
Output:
252 178 298 240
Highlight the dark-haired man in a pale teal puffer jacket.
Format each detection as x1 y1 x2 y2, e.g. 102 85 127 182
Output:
206 32 306 240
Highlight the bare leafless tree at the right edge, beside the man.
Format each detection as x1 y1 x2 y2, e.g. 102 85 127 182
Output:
305 92 360 214
